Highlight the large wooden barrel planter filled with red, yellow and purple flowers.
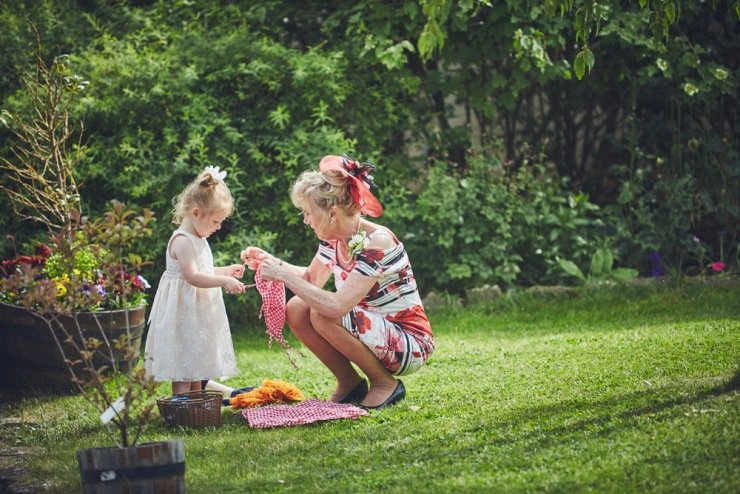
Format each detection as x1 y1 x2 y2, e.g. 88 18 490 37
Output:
0 201 153 392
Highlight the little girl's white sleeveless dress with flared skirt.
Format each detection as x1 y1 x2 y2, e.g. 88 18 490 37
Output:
144 230 237 381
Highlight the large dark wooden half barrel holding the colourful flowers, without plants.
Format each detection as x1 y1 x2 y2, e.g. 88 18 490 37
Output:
0 303 146 393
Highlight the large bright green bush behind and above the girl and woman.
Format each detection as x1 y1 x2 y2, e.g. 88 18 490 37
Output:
61 5 364 290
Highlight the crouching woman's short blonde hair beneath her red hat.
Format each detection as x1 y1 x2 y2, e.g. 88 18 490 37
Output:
290 170 360 215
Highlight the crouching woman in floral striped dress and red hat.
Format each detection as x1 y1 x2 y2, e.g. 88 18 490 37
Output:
241 156 434 410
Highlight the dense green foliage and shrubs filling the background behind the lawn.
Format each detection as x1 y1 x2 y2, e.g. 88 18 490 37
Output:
0 0 740 312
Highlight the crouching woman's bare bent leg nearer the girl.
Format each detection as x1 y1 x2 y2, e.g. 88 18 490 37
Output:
286 297 362 402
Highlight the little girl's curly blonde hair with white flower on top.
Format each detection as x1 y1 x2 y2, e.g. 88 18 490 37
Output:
172 171 234 225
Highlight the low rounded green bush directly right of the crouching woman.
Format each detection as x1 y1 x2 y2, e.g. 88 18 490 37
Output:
405 148 607 293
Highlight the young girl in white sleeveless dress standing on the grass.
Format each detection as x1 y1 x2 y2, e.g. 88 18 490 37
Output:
144 166 244 394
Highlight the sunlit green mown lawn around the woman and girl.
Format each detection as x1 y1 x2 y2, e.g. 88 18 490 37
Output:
0 283 740 493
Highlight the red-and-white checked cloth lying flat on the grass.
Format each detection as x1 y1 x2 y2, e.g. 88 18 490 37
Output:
241 398 369 429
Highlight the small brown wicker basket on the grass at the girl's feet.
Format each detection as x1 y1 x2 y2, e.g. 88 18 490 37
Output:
157 391 224 427
